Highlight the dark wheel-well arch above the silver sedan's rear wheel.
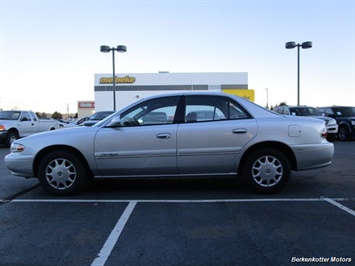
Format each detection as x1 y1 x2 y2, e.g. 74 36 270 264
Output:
237 141 297 173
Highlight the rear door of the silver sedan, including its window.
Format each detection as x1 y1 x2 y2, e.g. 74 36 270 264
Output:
177 96 257 175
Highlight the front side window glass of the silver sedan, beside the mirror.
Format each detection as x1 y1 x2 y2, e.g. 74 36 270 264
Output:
121 97 179 126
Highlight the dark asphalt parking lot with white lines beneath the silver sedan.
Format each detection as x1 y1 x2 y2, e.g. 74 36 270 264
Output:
0 141 355 265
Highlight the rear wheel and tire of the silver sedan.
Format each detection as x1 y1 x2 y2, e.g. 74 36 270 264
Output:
242 148 291 194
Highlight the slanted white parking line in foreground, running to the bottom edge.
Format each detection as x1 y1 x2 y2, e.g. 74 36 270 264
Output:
91 201 137 266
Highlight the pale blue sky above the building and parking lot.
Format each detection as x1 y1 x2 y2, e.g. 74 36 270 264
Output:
0 0 355 113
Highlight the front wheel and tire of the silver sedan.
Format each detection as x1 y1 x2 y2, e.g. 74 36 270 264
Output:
38 151 87 196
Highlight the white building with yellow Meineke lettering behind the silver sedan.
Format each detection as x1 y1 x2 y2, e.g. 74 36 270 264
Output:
78 72 254 117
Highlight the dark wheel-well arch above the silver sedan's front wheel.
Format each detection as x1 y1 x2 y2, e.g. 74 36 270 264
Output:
33 145 92 177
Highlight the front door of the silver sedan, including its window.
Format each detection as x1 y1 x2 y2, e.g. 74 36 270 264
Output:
95 97 179 177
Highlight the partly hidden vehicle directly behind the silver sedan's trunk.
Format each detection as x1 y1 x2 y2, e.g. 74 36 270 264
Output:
273 105 338 141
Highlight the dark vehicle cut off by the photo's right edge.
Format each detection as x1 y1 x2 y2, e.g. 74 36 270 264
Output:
317 106 355 141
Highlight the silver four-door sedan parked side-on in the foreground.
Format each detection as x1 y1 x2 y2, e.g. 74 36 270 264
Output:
5 92 334 195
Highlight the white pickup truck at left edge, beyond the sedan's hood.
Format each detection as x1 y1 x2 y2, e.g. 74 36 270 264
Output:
0 110 59 147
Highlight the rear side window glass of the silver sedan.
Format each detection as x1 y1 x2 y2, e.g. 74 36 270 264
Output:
185 96 250 123
